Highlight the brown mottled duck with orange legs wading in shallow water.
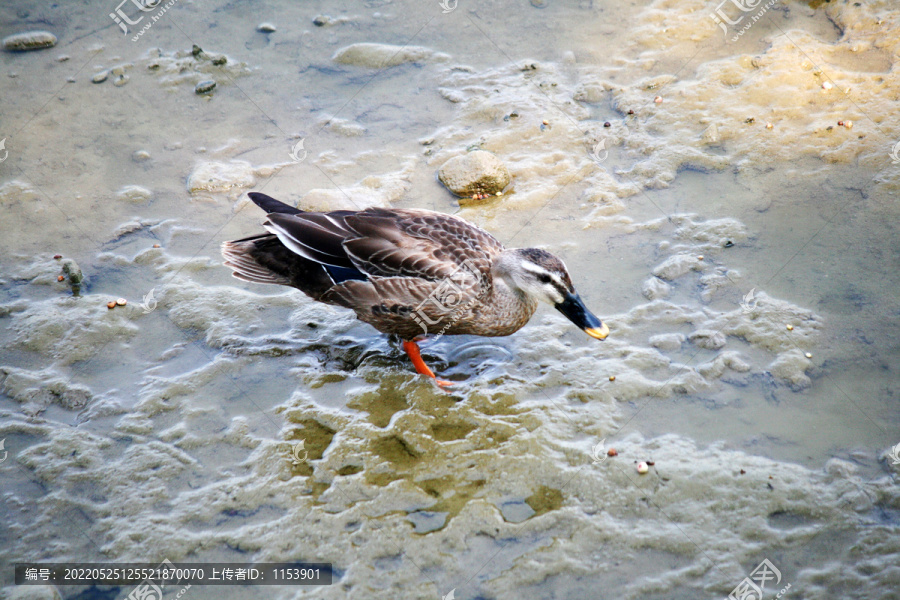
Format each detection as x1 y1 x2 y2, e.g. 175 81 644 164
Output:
222 192 609 386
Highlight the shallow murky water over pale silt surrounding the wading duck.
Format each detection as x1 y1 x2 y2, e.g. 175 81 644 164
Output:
0 0 900 599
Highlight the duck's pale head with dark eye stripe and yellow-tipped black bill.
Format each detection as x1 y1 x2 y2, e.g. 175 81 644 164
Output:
495 248 609 340
